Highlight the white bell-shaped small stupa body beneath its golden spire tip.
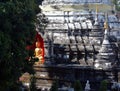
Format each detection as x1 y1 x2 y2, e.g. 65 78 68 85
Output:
94 29 115 69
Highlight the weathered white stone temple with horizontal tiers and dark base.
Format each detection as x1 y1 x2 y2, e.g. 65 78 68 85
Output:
35 0 120 91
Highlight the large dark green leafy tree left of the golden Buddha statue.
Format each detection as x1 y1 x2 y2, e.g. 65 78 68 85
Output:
0 0 40 91
